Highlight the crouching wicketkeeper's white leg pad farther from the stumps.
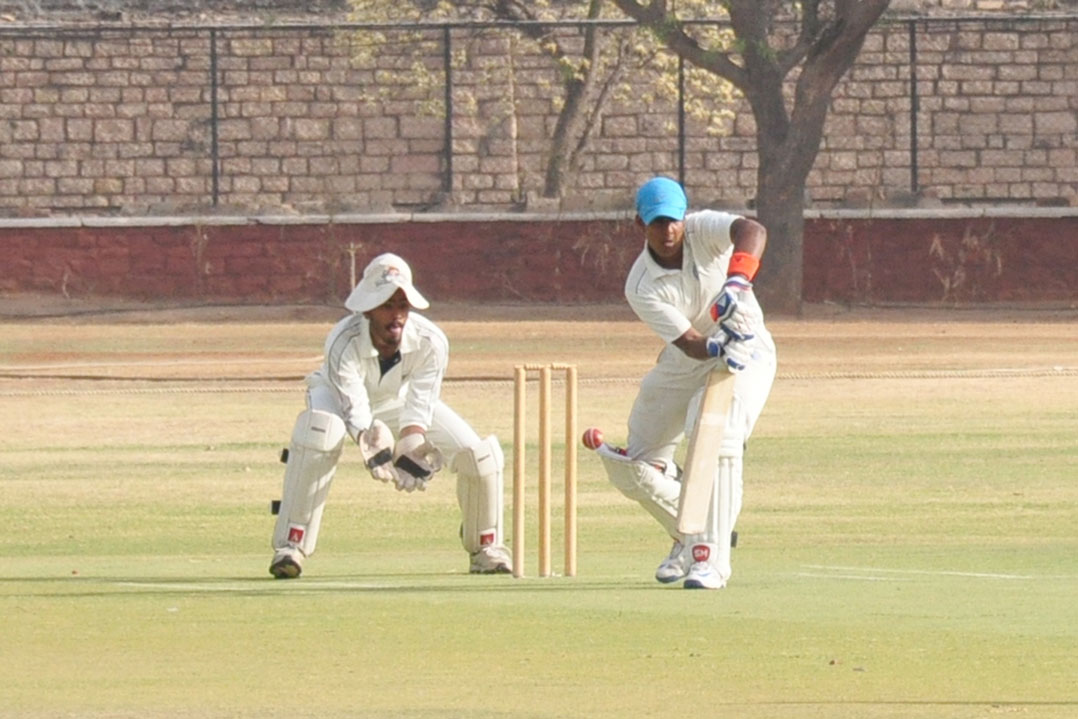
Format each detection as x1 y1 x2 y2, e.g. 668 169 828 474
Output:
273 410 347 556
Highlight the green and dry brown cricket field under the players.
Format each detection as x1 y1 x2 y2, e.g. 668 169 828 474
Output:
0 301 1078 719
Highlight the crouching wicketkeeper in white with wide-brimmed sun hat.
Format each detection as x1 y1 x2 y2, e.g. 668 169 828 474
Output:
270 253 511 579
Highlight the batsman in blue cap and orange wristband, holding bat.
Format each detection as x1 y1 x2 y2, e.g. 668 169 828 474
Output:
596 177 776 590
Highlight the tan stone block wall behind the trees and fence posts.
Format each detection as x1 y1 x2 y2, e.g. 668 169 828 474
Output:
0 17 1078 216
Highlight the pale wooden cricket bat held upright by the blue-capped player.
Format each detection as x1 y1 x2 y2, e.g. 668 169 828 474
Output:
677 368 734 535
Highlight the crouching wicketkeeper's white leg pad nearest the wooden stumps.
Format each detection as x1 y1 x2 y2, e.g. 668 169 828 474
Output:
452 434 506 554
